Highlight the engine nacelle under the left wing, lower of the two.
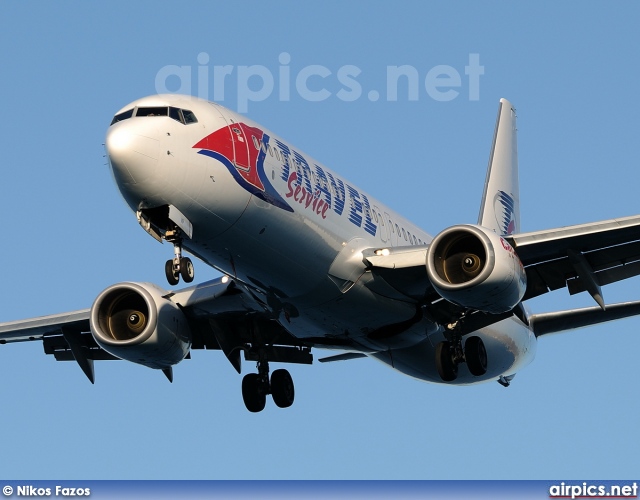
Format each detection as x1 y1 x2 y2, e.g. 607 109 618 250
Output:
90 283 191 369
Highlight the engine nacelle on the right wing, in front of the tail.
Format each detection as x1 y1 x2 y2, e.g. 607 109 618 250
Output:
427 225 527 314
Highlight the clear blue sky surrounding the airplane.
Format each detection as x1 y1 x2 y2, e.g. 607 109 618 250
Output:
0 1 640 479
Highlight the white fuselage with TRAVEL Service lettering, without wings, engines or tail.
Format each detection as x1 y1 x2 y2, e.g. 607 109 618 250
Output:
106 95 536 384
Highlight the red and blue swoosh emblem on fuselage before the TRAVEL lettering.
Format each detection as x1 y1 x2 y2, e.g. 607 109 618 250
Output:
193 123 293 212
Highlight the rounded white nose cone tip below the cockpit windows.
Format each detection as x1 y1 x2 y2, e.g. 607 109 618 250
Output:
105 122 160 186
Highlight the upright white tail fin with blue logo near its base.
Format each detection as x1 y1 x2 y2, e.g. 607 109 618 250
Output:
478 99 520 235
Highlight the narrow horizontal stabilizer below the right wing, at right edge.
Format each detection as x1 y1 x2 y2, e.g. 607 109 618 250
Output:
529 301 640 337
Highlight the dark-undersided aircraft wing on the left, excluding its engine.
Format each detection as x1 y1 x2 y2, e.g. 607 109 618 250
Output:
0 278 318 383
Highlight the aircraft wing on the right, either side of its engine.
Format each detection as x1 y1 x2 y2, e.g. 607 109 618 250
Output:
363 216 640 306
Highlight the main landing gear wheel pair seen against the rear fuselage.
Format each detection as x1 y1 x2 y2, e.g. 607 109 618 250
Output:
436 335 487 382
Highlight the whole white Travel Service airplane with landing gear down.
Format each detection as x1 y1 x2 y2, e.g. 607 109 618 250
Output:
0 94 640 413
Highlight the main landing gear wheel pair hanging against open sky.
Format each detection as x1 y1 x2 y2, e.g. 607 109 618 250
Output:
242 352 295 413
